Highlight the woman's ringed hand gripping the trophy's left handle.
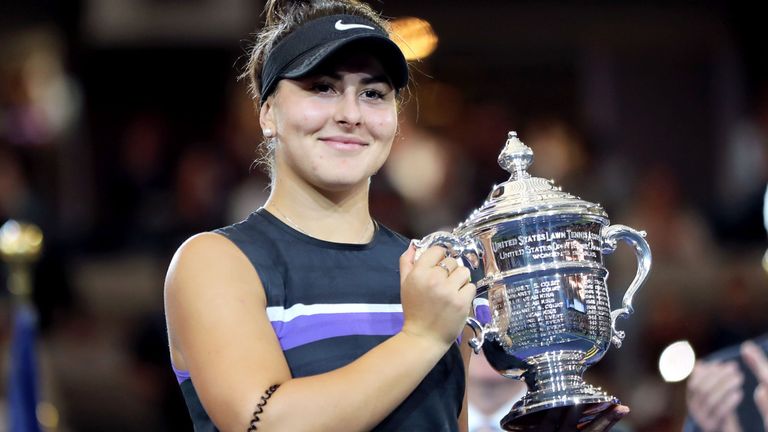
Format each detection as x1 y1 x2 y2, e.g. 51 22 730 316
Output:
400 245 476 345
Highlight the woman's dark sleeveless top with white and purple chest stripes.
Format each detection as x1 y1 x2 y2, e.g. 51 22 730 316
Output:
176 209 465 431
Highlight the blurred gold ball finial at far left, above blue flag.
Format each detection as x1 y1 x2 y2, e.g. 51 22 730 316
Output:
0 220 43 301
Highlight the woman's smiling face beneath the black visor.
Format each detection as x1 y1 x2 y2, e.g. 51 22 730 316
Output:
260 55 397 191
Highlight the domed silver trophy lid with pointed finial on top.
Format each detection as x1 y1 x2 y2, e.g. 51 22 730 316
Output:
456 131 608 234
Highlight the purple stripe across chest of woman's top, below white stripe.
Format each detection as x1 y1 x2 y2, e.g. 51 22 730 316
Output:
272 312 403 350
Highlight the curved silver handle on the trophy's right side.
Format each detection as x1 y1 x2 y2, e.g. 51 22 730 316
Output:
602 225 651 348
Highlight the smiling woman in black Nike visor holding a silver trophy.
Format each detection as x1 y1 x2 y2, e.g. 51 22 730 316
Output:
165 0 628 431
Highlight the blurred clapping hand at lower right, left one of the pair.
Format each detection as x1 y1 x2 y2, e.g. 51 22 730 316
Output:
686 361 744 432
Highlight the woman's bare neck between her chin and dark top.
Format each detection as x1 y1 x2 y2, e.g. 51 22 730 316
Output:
264 178 375 244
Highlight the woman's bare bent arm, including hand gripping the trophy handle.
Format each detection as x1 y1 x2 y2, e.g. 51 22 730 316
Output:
165 234 475 431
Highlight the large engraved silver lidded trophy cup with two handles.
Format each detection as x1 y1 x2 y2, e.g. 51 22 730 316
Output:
416 132 651 431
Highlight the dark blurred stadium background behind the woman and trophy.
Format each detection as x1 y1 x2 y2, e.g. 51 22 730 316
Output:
0 0 768 431
